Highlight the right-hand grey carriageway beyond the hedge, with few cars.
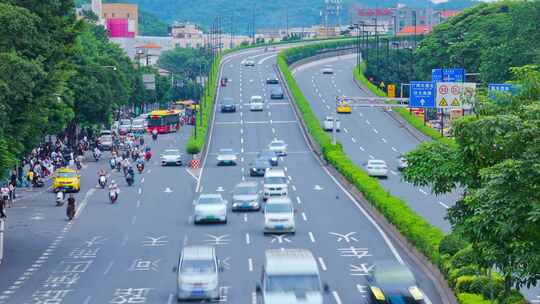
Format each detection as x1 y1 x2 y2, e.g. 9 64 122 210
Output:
293 55 458 231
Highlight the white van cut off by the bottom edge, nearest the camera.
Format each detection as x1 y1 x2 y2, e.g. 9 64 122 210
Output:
256 249 329 304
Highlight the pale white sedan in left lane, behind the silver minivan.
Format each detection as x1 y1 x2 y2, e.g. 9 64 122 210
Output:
193 194 228 224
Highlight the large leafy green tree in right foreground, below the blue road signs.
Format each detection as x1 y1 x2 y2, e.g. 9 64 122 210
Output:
404 66 540 292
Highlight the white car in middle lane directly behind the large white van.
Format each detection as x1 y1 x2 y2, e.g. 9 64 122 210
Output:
264 197 296 233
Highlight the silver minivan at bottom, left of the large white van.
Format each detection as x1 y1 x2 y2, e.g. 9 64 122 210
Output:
177 246 221 301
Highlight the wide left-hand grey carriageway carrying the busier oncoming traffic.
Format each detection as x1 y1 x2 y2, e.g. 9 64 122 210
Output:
0 50 442 304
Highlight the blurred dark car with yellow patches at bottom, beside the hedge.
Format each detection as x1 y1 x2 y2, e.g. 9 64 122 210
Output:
368 261 424 304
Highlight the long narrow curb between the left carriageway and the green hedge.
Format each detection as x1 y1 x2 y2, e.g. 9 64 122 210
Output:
275 51 458 304
